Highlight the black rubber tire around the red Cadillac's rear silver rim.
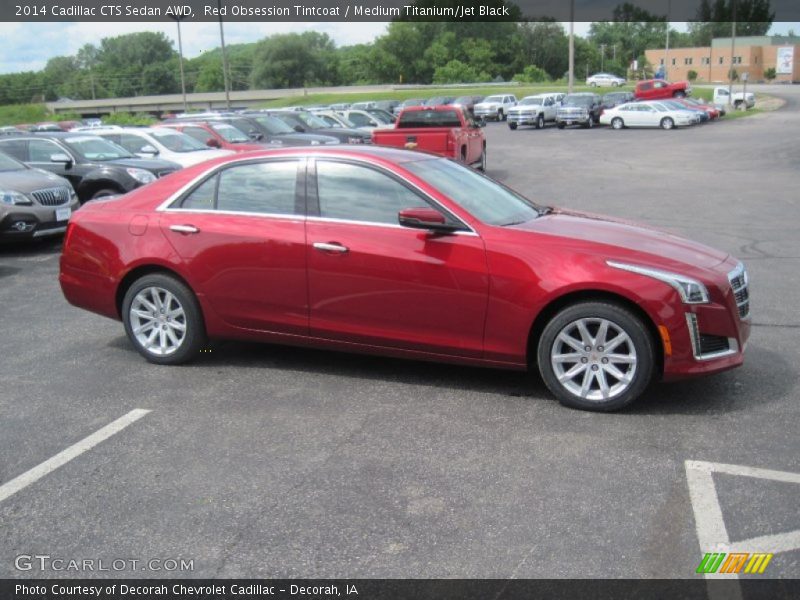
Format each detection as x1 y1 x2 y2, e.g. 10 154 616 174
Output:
122 273 207 365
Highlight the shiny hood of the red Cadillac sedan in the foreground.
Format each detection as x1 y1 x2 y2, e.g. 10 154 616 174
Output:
514 209 728 269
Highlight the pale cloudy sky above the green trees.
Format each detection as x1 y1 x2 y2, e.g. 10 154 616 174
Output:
0 22 800 73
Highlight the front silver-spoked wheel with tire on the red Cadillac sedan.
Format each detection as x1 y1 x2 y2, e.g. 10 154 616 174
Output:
537 302 655 411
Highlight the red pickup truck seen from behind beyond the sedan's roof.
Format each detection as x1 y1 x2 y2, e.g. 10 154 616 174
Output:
372 105 486 171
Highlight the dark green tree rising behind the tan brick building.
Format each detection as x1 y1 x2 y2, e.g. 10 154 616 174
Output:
689 0 775 46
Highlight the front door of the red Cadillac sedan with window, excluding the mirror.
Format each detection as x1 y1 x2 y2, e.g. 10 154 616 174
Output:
307 159 489 357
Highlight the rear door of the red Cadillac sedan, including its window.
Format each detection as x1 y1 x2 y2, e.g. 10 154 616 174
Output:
160 159 308 335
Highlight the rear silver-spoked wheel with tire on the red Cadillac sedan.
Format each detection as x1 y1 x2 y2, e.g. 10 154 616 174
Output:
122 273 206 365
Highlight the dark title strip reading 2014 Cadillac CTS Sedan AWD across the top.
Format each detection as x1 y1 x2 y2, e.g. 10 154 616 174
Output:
0 0 800 22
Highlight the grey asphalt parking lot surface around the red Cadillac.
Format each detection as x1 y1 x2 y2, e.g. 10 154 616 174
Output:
0 86 800 578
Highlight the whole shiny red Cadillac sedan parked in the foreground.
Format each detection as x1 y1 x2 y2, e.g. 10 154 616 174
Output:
60 146 750 410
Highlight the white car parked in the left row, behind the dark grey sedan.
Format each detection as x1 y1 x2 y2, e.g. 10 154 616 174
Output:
92 127 233 167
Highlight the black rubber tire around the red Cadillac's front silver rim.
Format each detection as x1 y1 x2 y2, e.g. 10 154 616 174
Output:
537 301 655 412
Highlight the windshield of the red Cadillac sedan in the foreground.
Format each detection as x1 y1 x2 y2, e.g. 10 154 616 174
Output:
403 158 541 227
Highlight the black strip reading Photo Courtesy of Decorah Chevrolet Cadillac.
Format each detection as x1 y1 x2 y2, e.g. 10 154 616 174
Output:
0 576 800 600
